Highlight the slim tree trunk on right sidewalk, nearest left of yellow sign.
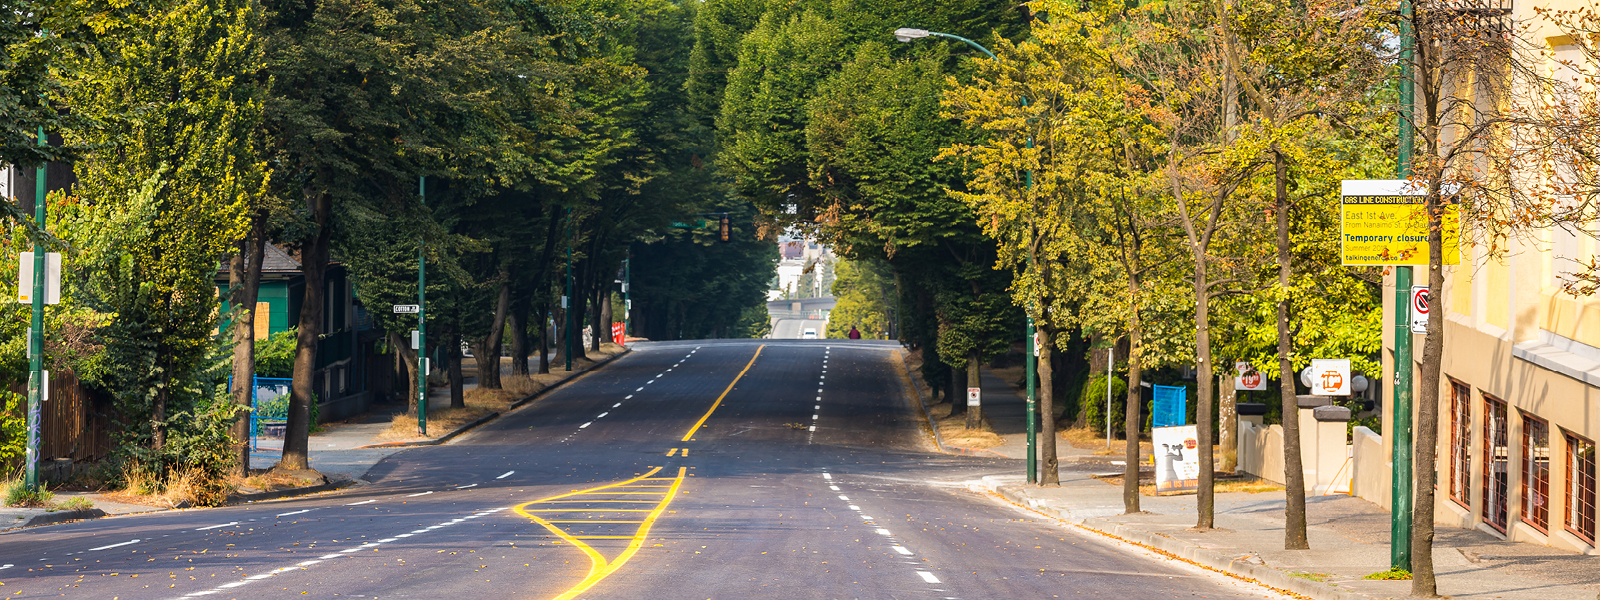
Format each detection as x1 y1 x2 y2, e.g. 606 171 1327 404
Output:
1272 149 1310 550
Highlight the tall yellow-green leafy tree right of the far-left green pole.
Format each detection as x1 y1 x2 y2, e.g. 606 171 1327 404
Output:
62 0 267 489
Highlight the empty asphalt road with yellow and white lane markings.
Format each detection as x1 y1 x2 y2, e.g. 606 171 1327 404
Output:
0 339 1277 600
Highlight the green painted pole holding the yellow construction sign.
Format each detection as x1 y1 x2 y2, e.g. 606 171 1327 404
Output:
1389 2 1432 571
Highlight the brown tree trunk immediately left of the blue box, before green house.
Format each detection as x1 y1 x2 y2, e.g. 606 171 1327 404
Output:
227 211 267 477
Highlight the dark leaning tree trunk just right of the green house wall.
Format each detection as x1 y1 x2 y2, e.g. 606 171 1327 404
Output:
278 192 333 469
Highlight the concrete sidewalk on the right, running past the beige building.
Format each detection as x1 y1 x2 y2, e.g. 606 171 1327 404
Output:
960 366 1600 600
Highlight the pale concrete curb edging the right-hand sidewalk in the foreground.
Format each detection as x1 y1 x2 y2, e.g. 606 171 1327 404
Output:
986 478 1373 600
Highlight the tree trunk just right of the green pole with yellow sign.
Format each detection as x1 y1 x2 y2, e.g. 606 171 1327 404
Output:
1411 178 1446 598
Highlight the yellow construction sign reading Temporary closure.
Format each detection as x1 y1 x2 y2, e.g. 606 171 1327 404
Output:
1339 179 1461 267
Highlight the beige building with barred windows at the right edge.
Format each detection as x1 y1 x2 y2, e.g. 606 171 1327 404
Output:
1358 0 1600 554
